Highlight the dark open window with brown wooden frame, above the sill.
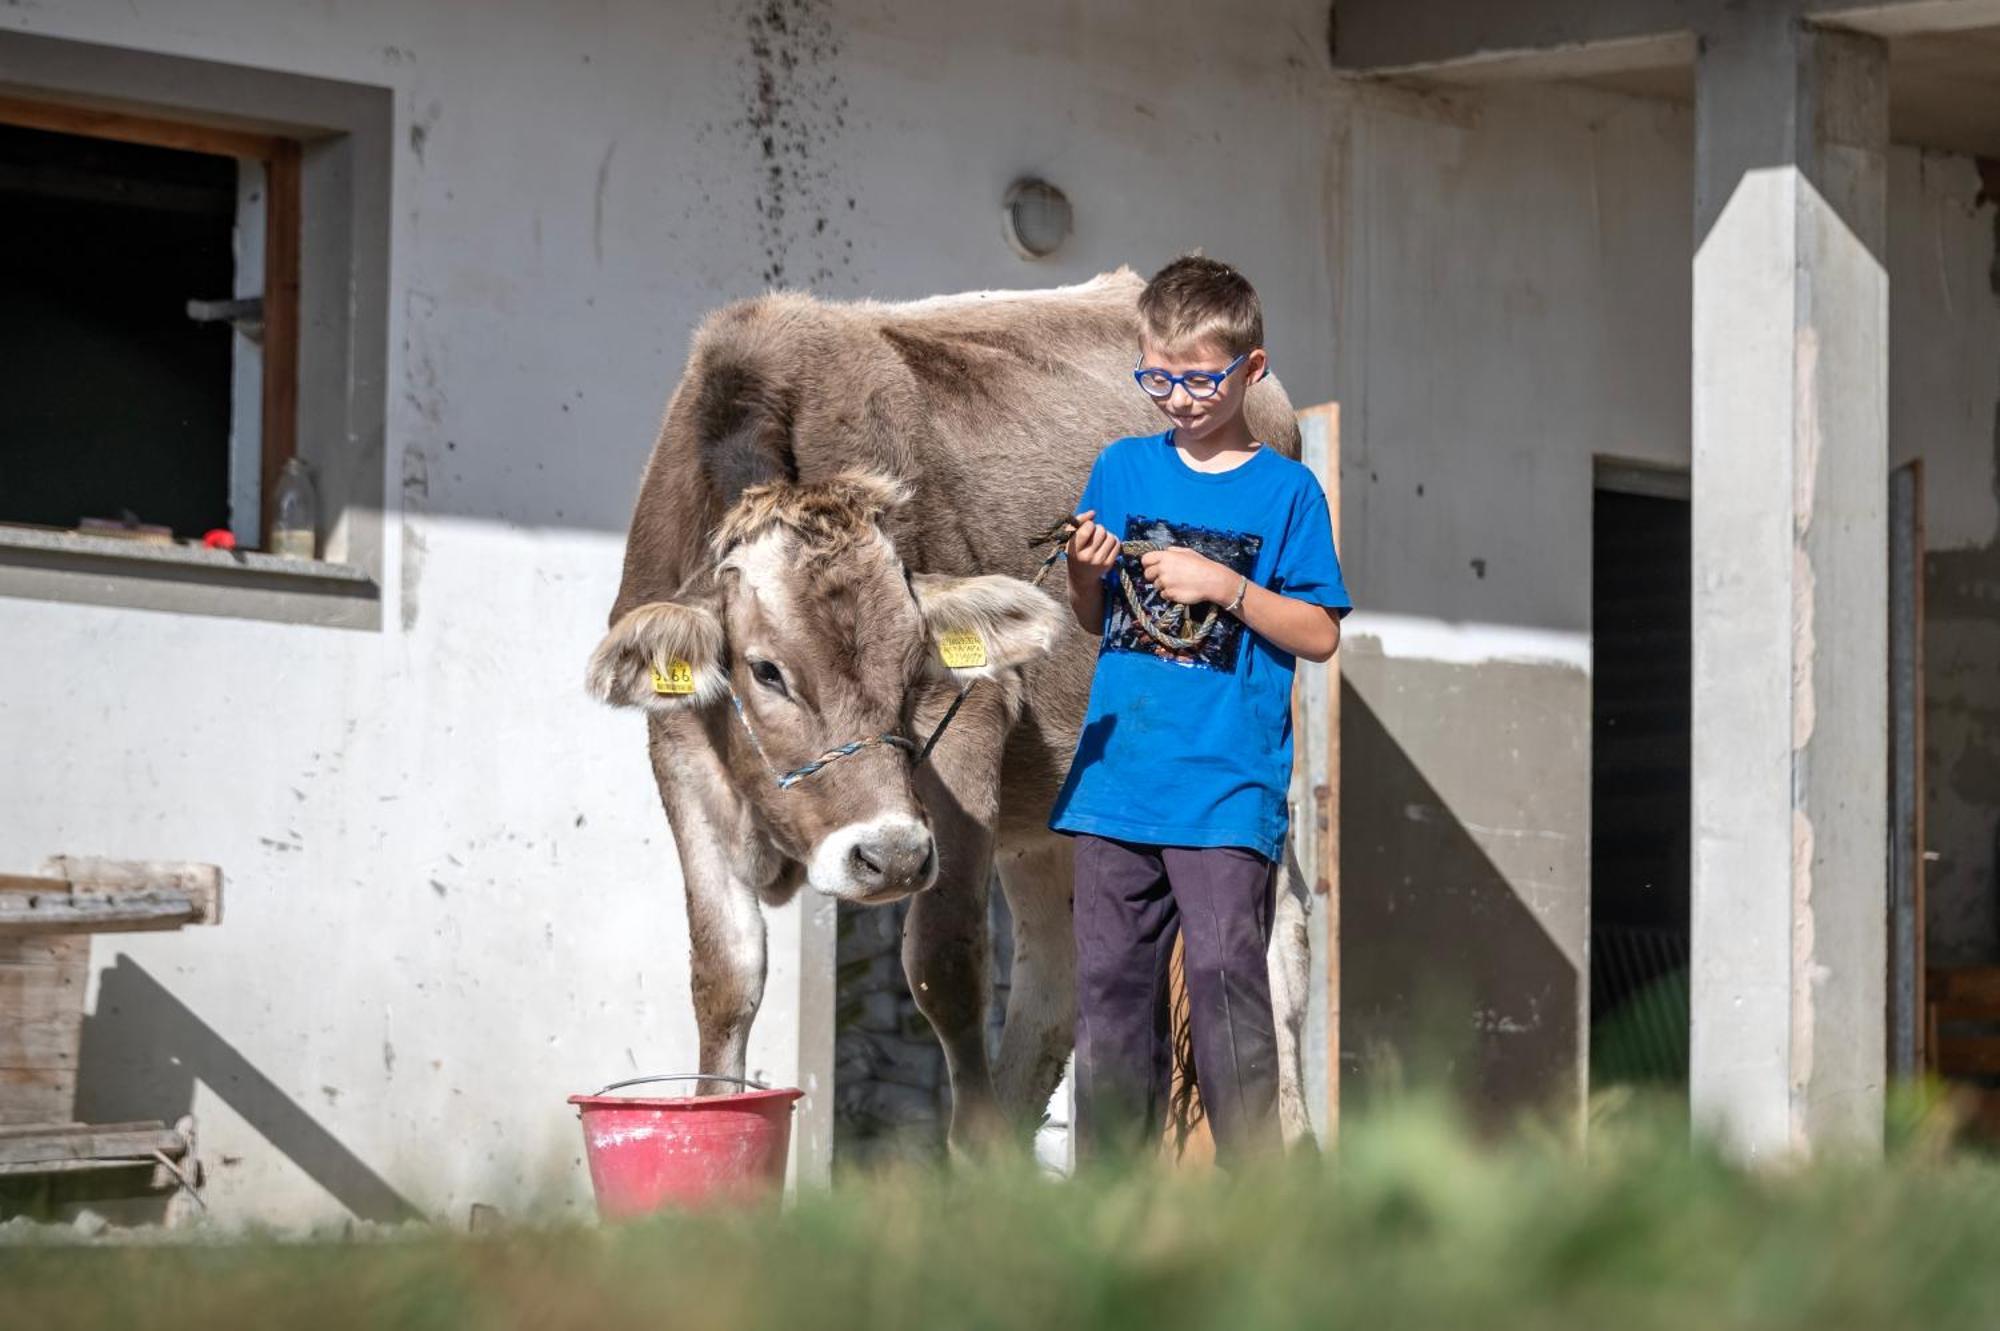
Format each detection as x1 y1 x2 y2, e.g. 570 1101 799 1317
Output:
0 98 300 548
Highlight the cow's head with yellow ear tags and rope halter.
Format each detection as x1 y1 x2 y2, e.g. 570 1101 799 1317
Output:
590 476 1062 903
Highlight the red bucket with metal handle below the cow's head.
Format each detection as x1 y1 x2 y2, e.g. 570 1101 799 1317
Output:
570 1073 804 1219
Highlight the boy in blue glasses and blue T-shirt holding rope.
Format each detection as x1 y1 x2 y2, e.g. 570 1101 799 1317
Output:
1050 256 1350 1163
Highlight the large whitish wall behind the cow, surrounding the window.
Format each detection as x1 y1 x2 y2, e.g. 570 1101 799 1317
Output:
0 0 1336 1221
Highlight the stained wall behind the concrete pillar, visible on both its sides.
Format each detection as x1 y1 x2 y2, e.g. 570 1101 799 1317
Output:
1338 69 2000 1111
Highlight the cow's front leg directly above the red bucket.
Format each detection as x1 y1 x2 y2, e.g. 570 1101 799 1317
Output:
650 717 782 1093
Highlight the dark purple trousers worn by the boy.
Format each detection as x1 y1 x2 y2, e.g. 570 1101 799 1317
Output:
1076 835 1278 1165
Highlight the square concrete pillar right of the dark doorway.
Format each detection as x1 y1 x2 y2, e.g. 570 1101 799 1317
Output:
1690 4 1888 1159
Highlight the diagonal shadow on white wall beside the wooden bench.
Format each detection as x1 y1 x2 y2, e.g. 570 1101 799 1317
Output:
76 955 422 1221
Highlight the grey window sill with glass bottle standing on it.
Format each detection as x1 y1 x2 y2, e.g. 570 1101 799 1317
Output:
0 526 382 630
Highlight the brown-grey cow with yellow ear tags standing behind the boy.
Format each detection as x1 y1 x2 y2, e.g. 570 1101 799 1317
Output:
588 270 1310 1151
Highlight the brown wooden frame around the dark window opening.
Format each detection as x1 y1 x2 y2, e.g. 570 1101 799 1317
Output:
0 96 302 548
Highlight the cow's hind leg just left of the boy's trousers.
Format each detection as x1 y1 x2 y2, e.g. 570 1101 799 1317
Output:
994 835 1076 1129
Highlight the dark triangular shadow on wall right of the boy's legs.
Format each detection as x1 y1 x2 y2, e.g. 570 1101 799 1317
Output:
1340 683 1582 1129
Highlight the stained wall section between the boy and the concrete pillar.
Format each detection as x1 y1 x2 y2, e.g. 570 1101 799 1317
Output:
1340 80 1692 1111
